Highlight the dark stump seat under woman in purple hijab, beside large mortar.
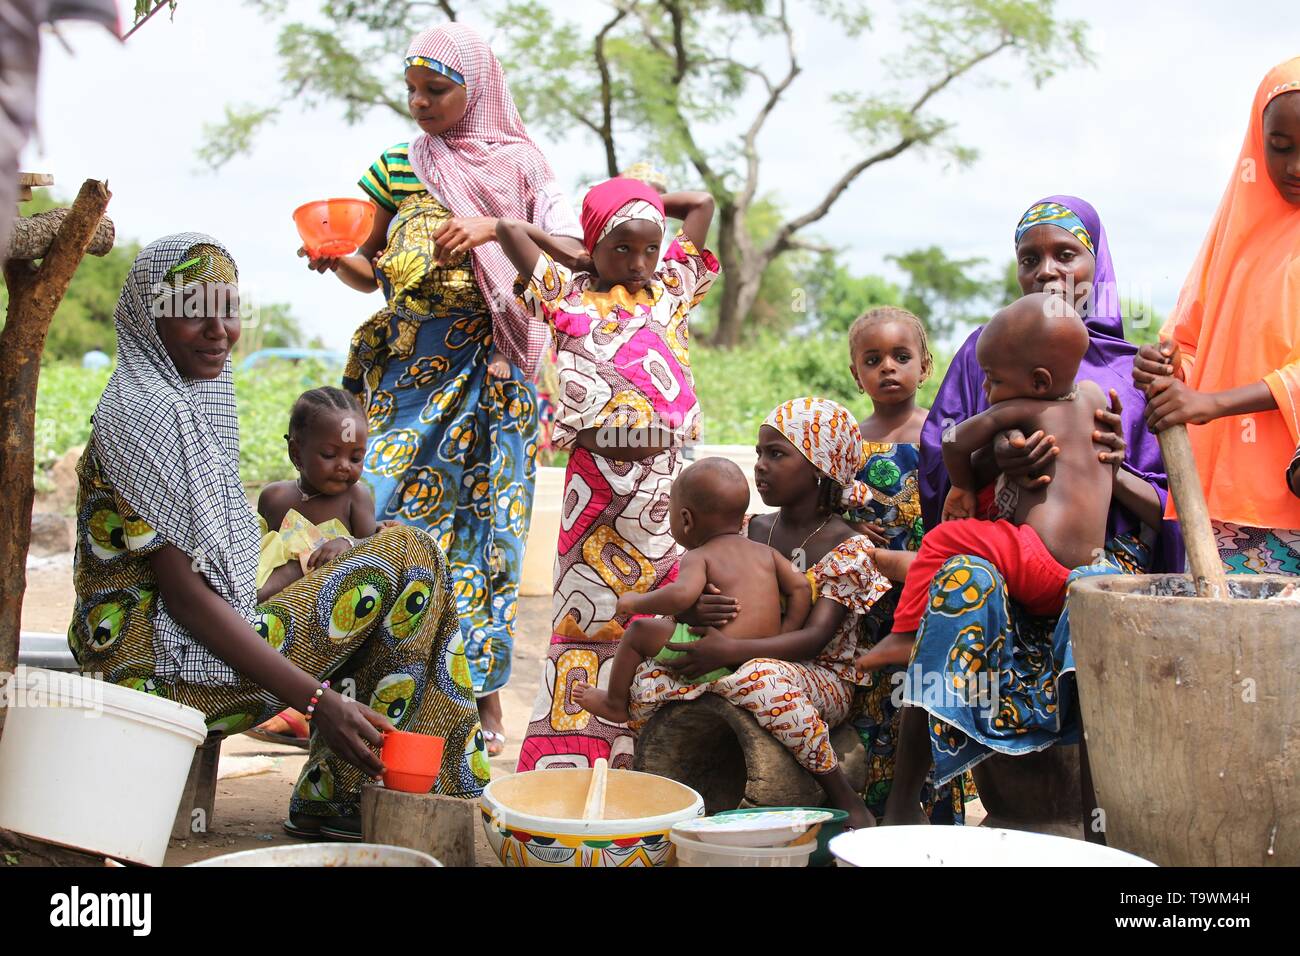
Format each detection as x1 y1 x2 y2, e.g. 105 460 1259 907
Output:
971 744 1084 840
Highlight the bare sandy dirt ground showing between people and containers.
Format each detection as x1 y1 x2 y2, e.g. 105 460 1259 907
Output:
12 554 984 866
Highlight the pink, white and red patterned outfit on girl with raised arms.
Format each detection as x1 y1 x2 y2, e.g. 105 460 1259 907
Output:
519 233 719 770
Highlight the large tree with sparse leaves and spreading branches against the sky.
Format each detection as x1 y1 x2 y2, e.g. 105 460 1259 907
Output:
210 0 1091 345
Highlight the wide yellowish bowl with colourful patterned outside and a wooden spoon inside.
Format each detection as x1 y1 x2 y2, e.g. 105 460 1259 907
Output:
480 769 705 866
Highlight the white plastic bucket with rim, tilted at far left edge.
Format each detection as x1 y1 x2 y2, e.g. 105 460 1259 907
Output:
0 667 208 866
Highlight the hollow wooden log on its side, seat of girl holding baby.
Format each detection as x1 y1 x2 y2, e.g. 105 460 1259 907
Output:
632 693 867 813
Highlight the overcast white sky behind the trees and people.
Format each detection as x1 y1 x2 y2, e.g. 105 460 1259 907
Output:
23 0 1300 347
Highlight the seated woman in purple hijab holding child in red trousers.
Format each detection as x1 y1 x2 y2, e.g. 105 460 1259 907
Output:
885 196 1182 823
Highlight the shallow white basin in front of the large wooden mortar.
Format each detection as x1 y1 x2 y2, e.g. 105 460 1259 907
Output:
826 826 1156 866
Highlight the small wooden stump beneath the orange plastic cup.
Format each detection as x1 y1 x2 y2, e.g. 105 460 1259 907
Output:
361 784 478 866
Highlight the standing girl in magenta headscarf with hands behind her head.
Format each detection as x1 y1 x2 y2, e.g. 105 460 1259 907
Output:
497 177 719 770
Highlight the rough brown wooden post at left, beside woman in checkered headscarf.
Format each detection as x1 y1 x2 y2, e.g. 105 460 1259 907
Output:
0 179 112 672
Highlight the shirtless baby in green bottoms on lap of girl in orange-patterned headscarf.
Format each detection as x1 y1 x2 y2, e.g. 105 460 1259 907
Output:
573 458 813 723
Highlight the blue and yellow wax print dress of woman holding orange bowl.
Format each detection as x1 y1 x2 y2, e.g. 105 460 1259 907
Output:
343 144 546 697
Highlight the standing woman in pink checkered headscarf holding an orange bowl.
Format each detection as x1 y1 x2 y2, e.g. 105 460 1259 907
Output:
300 23 582 767
